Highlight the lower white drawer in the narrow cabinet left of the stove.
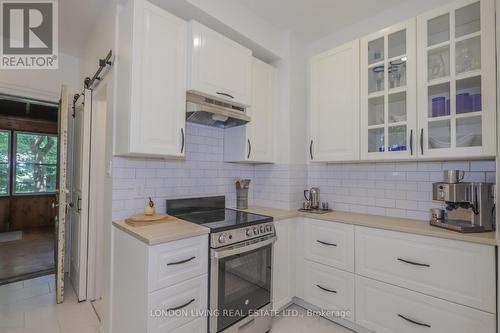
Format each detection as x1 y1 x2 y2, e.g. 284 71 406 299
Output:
148 274 208 333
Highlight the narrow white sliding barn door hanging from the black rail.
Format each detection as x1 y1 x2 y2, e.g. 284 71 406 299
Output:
70 89 92 301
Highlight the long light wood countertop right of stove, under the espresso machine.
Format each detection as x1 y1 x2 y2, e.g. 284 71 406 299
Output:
238 206 497 246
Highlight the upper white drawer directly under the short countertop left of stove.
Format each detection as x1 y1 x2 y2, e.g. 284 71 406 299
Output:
148 235 208 292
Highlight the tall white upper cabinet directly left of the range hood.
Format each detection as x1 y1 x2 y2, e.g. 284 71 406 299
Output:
115 0 187 157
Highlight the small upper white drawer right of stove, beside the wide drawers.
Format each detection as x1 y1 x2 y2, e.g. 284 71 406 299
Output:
304 218 354 272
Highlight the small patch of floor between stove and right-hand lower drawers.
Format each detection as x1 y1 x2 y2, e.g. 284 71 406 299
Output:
271 305 354 333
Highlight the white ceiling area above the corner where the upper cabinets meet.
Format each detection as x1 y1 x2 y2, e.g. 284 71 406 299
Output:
234 0 405 42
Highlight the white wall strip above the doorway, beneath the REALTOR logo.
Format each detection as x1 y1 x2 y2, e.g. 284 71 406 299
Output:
0 53 80 102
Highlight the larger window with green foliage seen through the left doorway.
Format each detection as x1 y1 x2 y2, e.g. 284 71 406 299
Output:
14 132 57 194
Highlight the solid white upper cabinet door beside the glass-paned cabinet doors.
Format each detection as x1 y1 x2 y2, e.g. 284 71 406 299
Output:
308 40 359 162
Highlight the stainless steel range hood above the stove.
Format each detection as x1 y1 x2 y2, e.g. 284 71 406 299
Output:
186 92 250 128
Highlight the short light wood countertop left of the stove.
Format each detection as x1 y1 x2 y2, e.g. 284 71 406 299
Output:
113 219 210 245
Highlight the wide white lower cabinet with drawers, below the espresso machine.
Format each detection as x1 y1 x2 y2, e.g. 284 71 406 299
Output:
294 218 497 333
